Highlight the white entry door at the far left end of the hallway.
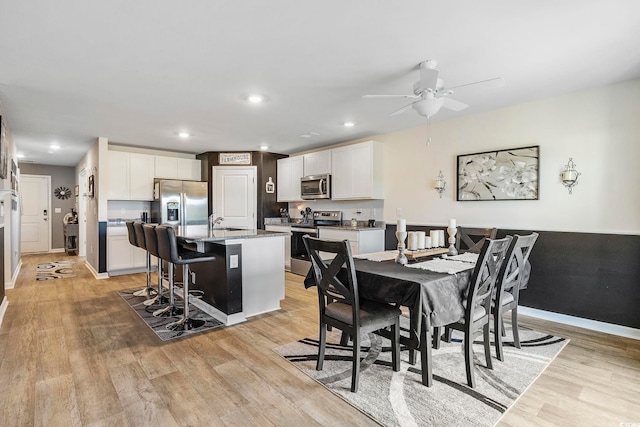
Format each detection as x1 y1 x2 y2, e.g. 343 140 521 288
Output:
20 175 51 252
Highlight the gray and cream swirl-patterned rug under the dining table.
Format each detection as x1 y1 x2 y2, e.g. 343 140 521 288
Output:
275 325 568 427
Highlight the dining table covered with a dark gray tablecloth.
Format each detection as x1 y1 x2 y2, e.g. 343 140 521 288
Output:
304 251 531 385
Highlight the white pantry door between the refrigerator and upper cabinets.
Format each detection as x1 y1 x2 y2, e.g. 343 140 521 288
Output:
211 166 257 229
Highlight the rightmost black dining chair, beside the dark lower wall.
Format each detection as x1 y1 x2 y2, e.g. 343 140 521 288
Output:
491 233 538 361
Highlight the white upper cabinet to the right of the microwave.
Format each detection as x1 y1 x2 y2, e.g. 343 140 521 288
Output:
331 141 384 200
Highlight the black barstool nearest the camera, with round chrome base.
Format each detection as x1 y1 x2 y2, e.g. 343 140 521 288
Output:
156 225 216 331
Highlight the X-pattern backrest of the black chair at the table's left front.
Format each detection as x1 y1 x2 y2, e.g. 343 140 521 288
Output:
302 235 360 327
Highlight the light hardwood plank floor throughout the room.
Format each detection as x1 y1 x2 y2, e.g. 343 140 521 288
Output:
0 254 640 427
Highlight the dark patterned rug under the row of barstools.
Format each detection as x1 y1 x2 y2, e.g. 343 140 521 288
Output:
118 288 223 341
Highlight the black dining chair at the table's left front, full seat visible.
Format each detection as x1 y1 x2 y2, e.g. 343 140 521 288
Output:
302 235 400 393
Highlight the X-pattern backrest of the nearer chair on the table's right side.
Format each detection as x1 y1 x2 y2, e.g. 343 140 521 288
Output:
465 236 511 319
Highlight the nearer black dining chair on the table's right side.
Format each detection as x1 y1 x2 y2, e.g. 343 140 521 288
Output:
434 236 511 388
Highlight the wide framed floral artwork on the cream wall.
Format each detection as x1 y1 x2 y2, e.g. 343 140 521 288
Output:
457 145 540 201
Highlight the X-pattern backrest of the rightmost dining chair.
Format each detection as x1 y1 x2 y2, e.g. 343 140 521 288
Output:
496 233 538 304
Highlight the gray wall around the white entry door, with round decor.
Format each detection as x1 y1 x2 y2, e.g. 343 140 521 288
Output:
20 163 76 249
